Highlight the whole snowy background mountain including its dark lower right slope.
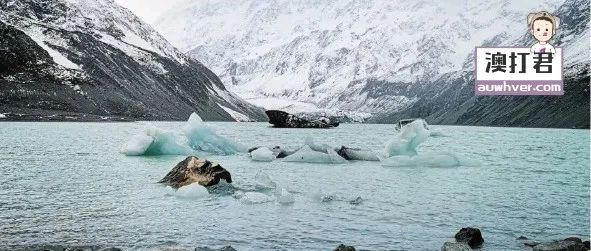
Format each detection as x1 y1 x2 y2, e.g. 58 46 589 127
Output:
154 0 589 127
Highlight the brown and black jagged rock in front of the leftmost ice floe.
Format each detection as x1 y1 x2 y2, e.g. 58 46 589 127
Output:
159 156 232 188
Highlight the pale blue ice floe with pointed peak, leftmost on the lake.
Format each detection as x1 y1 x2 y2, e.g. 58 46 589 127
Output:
121 113 247 156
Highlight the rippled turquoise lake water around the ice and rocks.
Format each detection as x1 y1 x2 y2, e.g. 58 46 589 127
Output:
0 122 590 250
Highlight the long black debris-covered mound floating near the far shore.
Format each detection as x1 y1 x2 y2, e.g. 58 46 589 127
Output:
265 110 339 128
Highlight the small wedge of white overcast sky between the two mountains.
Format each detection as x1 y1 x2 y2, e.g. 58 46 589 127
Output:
115 0 186 24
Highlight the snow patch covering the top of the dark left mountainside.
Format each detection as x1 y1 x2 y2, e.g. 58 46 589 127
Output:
0 0 186 63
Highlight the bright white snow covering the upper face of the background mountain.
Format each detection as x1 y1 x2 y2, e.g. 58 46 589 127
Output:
155 0 562 112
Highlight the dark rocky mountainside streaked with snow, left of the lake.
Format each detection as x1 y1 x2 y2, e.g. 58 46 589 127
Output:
0 0 265 120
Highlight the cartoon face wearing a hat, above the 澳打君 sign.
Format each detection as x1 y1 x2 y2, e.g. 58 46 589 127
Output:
527 11 560 43
